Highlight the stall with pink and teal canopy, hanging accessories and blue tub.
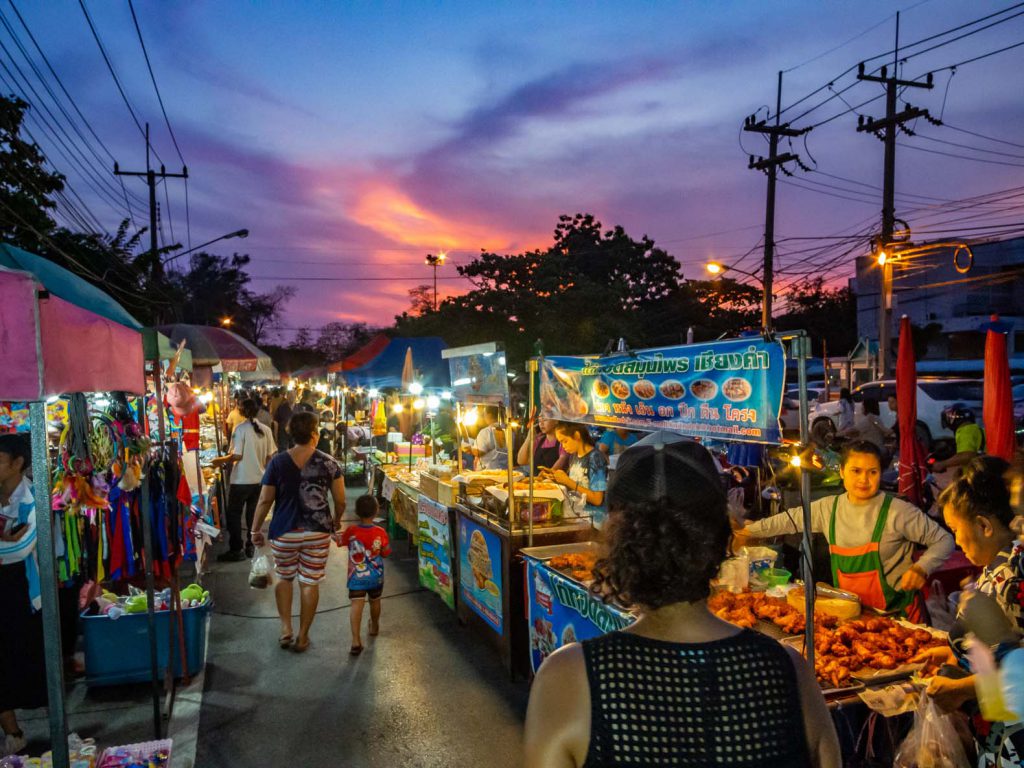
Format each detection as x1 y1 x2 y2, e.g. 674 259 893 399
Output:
0 260 209 766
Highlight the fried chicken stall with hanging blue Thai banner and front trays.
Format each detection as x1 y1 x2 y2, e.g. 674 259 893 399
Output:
522 334 958 755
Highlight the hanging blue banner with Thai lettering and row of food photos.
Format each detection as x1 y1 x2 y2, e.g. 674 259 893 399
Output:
541 337 785 443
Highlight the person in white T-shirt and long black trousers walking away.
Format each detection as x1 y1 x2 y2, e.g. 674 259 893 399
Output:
213 399 278 562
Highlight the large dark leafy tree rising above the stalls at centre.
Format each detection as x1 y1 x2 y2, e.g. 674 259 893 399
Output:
395 213 682 366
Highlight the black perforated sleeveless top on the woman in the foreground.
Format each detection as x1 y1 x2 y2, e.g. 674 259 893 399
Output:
583 630 810 768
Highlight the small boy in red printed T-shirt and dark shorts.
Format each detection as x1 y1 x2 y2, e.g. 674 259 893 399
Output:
340 496 391 656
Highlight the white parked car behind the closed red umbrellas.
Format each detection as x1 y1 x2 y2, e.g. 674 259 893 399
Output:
811 376 984 452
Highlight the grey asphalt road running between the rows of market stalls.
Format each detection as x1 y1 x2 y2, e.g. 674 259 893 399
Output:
196 518 528 768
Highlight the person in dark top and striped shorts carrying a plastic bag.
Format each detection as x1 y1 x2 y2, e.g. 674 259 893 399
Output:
251 412 345 653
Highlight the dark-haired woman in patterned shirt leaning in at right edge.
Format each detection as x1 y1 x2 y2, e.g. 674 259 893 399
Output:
926 457 1024 768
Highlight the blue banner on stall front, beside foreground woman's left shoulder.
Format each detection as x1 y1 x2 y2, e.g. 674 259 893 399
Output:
526 558 634 672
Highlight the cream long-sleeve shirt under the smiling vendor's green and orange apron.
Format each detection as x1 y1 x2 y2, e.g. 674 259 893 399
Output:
745 494 953 587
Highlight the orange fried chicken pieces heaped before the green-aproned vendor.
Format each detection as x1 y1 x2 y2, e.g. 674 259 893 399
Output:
708 592 946 688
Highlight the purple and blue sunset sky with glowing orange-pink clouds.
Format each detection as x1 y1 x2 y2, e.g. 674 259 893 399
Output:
8 0 1024 338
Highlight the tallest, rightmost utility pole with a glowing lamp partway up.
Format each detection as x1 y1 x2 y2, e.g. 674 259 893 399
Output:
857 13 934 379
